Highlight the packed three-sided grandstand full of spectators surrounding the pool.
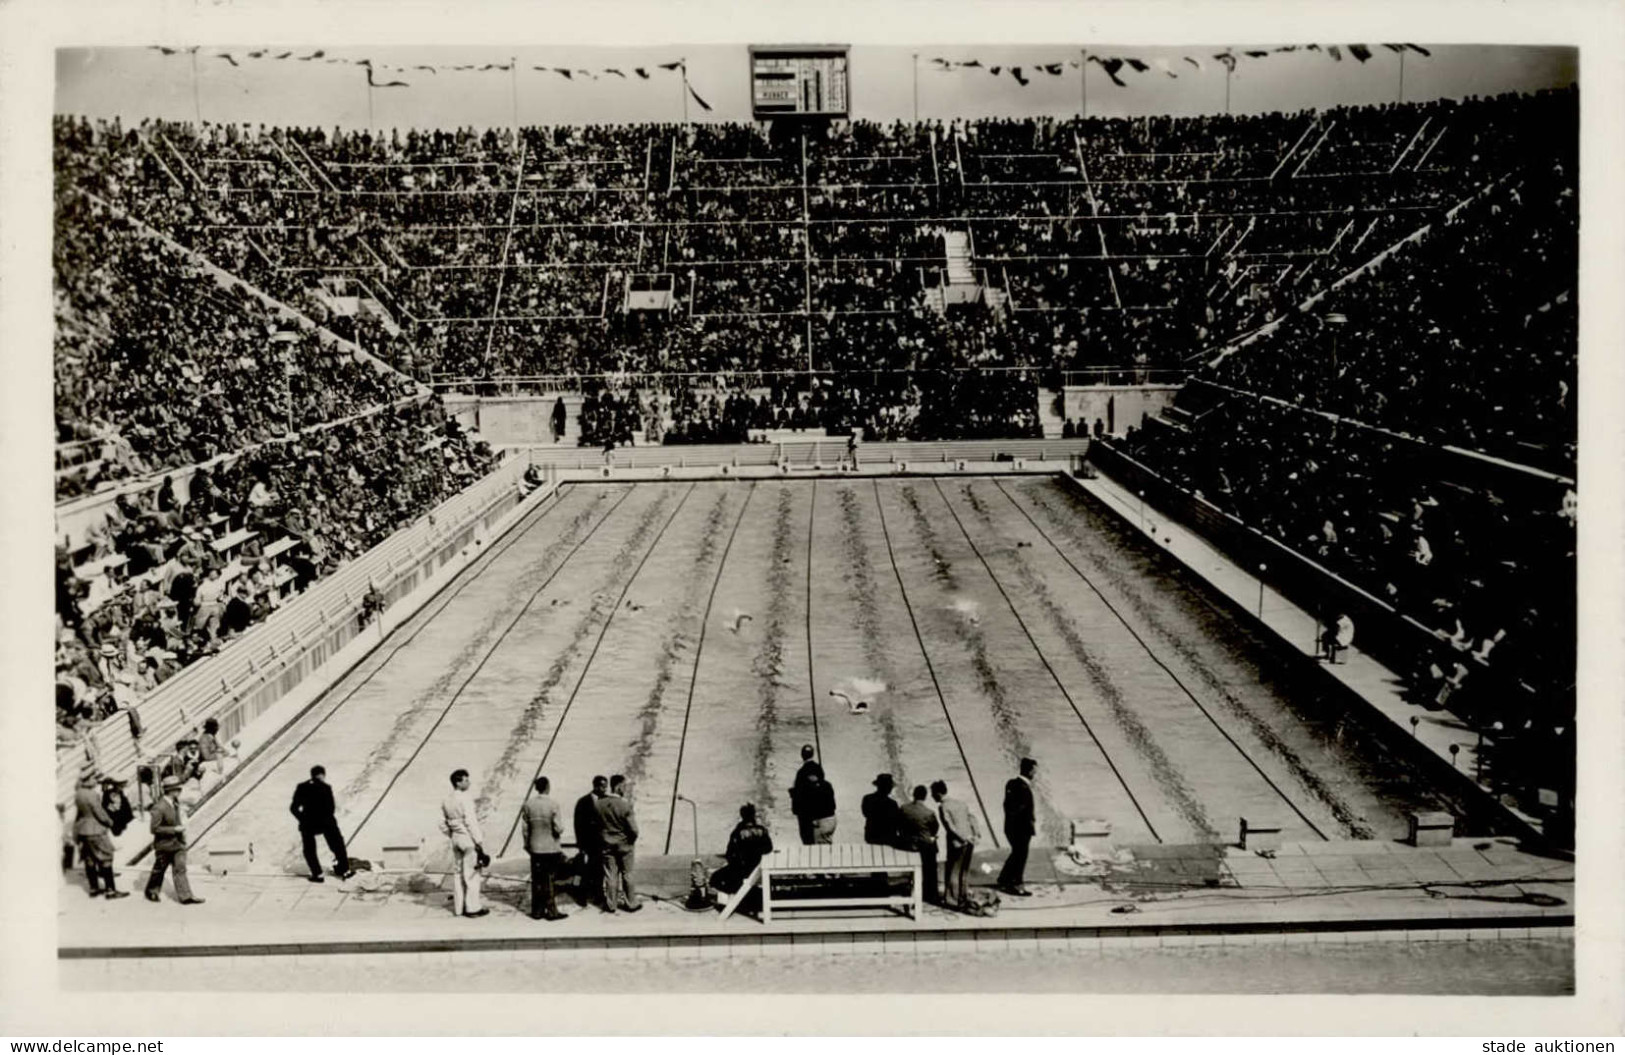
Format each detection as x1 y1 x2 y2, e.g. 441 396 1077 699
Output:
54 71 1578 838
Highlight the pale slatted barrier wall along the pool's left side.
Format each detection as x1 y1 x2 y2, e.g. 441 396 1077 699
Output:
57 458 546 801
